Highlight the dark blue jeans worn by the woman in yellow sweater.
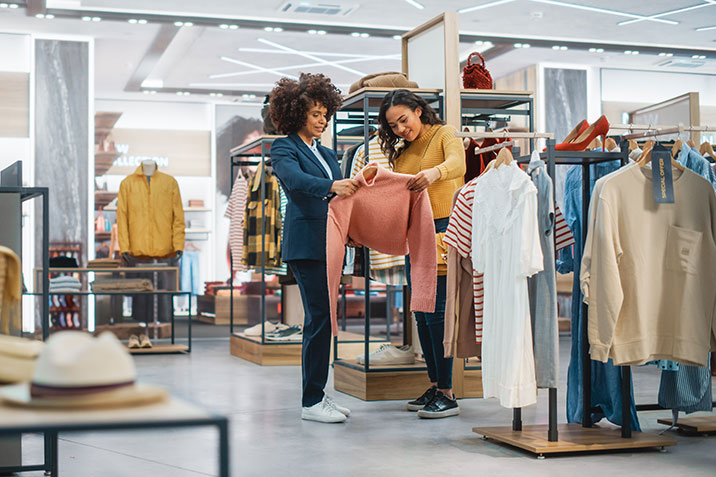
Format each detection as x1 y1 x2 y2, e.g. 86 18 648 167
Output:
405 217 452 389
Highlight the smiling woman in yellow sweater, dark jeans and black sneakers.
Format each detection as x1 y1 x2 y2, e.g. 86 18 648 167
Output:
378 89 465 418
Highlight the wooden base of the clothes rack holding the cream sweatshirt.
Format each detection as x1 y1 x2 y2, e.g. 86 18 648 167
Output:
472 424 676 457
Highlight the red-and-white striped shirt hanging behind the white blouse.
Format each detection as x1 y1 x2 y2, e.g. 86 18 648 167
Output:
443 178 574 343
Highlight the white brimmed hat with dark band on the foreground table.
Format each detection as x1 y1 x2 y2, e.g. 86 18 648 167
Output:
0 331 168 409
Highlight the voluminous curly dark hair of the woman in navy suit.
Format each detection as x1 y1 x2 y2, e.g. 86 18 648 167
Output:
269 73 343 134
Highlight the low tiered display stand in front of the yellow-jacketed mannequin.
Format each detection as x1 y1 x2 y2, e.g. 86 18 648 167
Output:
32 267 192 354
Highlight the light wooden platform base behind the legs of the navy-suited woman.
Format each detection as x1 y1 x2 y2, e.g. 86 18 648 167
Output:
231 331 387 366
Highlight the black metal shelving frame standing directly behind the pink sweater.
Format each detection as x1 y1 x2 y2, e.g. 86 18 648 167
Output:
333 90 444 373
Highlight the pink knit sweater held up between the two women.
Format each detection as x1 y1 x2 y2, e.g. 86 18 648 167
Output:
326 162 437 335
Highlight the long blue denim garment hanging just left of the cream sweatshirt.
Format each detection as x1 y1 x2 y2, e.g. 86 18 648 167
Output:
557 153 641 431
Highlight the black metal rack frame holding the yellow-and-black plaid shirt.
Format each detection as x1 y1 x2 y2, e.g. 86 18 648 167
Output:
229 135 286 345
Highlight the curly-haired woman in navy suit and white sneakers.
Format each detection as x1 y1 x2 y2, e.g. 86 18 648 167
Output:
270 73 359 422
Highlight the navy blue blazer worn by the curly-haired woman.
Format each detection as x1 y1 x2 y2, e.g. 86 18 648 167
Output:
271 134 343 262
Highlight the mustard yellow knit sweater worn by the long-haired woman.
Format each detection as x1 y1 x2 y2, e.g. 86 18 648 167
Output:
394 124 465 219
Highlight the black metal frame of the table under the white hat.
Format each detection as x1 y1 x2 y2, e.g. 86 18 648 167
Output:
0 415 230 477
